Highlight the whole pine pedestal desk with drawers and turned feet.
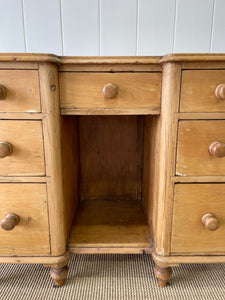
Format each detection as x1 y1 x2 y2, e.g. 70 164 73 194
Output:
0 54 225 286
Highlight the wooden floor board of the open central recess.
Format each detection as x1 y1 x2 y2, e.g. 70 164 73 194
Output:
68 200 152 253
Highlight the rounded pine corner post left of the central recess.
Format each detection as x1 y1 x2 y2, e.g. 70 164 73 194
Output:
39 63 68 256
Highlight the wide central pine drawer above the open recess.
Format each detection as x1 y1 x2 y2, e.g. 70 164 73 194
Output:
59 72 161 109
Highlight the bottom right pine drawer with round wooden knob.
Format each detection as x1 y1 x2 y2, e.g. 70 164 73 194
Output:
171 184 225 255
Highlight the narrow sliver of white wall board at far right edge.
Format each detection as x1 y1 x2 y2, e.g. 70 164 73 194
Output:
212 0 225 53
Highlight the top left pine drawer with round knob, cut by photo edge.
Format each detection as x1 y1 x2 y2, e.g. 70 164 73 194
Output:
0 70 41 112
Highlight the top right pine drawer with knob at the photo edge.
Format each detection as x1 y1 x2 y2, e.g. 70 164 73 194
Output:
180 70 225 112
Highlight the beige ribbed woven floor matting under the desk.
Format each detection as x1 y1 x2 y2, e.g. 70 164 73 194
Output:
0 255 225 300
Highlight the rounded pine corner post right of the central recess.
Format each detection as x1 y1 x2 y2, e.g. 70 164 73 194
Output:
153 63 181 255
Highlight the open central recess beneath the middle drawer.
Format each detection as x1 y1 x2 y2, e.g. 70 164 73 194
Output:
62 116 156 253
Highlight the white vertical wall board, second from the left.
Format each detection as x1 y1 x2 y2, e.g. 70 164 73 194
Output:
23 0 62 55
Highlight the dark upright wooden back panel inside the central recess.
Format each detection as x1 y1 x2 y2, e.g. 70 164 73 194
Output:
79 116 142 199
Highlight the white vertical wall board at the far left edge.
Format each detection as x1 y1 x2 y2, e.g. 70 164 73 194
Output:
0 0 25 52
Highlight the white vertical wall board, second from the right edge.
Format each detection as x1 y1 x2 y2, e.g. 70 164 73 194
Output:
174 0 213 53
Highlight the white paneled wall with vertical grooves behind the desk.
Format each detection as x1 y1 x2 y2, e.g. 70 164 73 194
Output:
0 0 225 55
